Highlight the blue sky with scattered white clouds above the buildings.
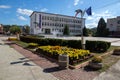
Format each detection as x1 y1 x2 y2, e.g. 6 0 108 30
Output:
0 0 120 28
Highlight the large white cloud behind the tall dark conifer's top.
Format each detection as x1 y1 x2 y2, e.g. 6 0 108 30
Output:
86 10 115 27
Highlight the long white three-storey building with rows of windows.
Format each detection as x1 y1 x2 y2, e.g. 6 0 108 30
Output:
30 11 85 36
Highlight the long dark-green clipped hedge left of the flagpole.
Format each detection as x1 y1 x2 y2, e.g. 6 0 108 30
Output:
20 36 81 49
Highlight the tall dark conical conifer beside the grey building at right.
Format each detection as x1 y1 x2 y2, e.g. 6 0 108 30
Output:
96 18 109 37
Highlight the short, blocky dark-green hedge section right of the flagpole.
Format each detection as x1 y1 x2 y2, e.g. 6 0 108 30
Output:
85 40 111 53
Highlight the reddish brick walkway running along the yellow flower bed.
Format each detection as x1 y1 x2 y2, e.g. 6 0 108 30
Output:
11 44 99 80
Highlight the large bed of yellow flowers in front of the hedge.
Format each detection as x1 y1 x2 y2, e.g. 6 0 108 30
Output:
36 46 92 65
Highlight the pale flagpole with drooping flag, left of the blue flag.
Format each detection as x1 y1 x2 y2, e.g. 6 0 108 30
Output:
75 9 85 49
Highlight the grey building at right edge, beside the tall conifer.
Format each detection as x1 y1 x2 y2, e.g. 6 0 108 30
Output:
107 16 120 36
